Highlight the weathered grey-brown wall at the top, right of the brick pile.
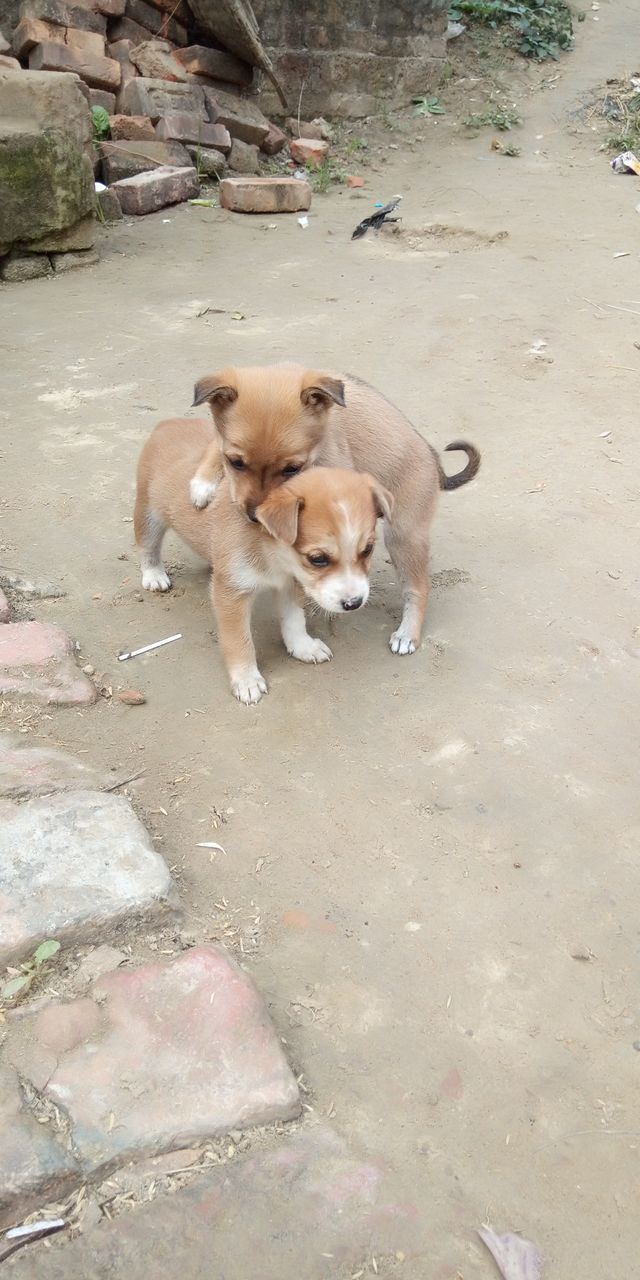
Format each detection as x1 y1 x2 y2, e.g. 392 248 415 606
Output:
252 0 448 119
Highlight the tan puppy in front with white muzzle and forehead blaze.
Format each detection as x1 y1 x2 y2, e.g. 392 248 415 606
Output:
134 420 393 704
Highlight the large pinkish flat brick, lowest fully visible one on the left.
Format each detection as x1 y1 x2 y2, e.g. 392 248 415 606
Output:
8 947 300 1176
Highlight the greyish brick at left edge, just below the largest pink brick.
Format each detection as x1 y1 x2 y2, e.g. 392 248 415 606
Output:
0 1066 79 1229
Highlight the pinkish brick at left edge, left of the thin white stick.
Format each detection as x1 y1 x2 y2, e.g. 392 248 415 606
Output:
0 616 96 701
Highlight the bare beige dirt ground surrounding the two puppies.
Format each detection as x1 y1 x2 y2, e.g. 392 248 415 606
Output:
0 0 640 1280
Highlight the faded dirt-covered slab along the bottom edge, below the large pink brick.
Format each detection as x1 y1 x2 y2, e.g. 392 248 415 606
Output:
9 1126 424 1280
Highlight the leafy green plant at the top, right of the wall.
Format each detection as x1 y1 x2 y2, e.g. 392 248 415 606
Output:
449 0 573 61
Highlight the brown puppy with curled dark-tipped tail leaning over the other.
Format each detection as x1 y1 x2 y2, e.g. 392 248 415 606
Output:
191 365 480 654
